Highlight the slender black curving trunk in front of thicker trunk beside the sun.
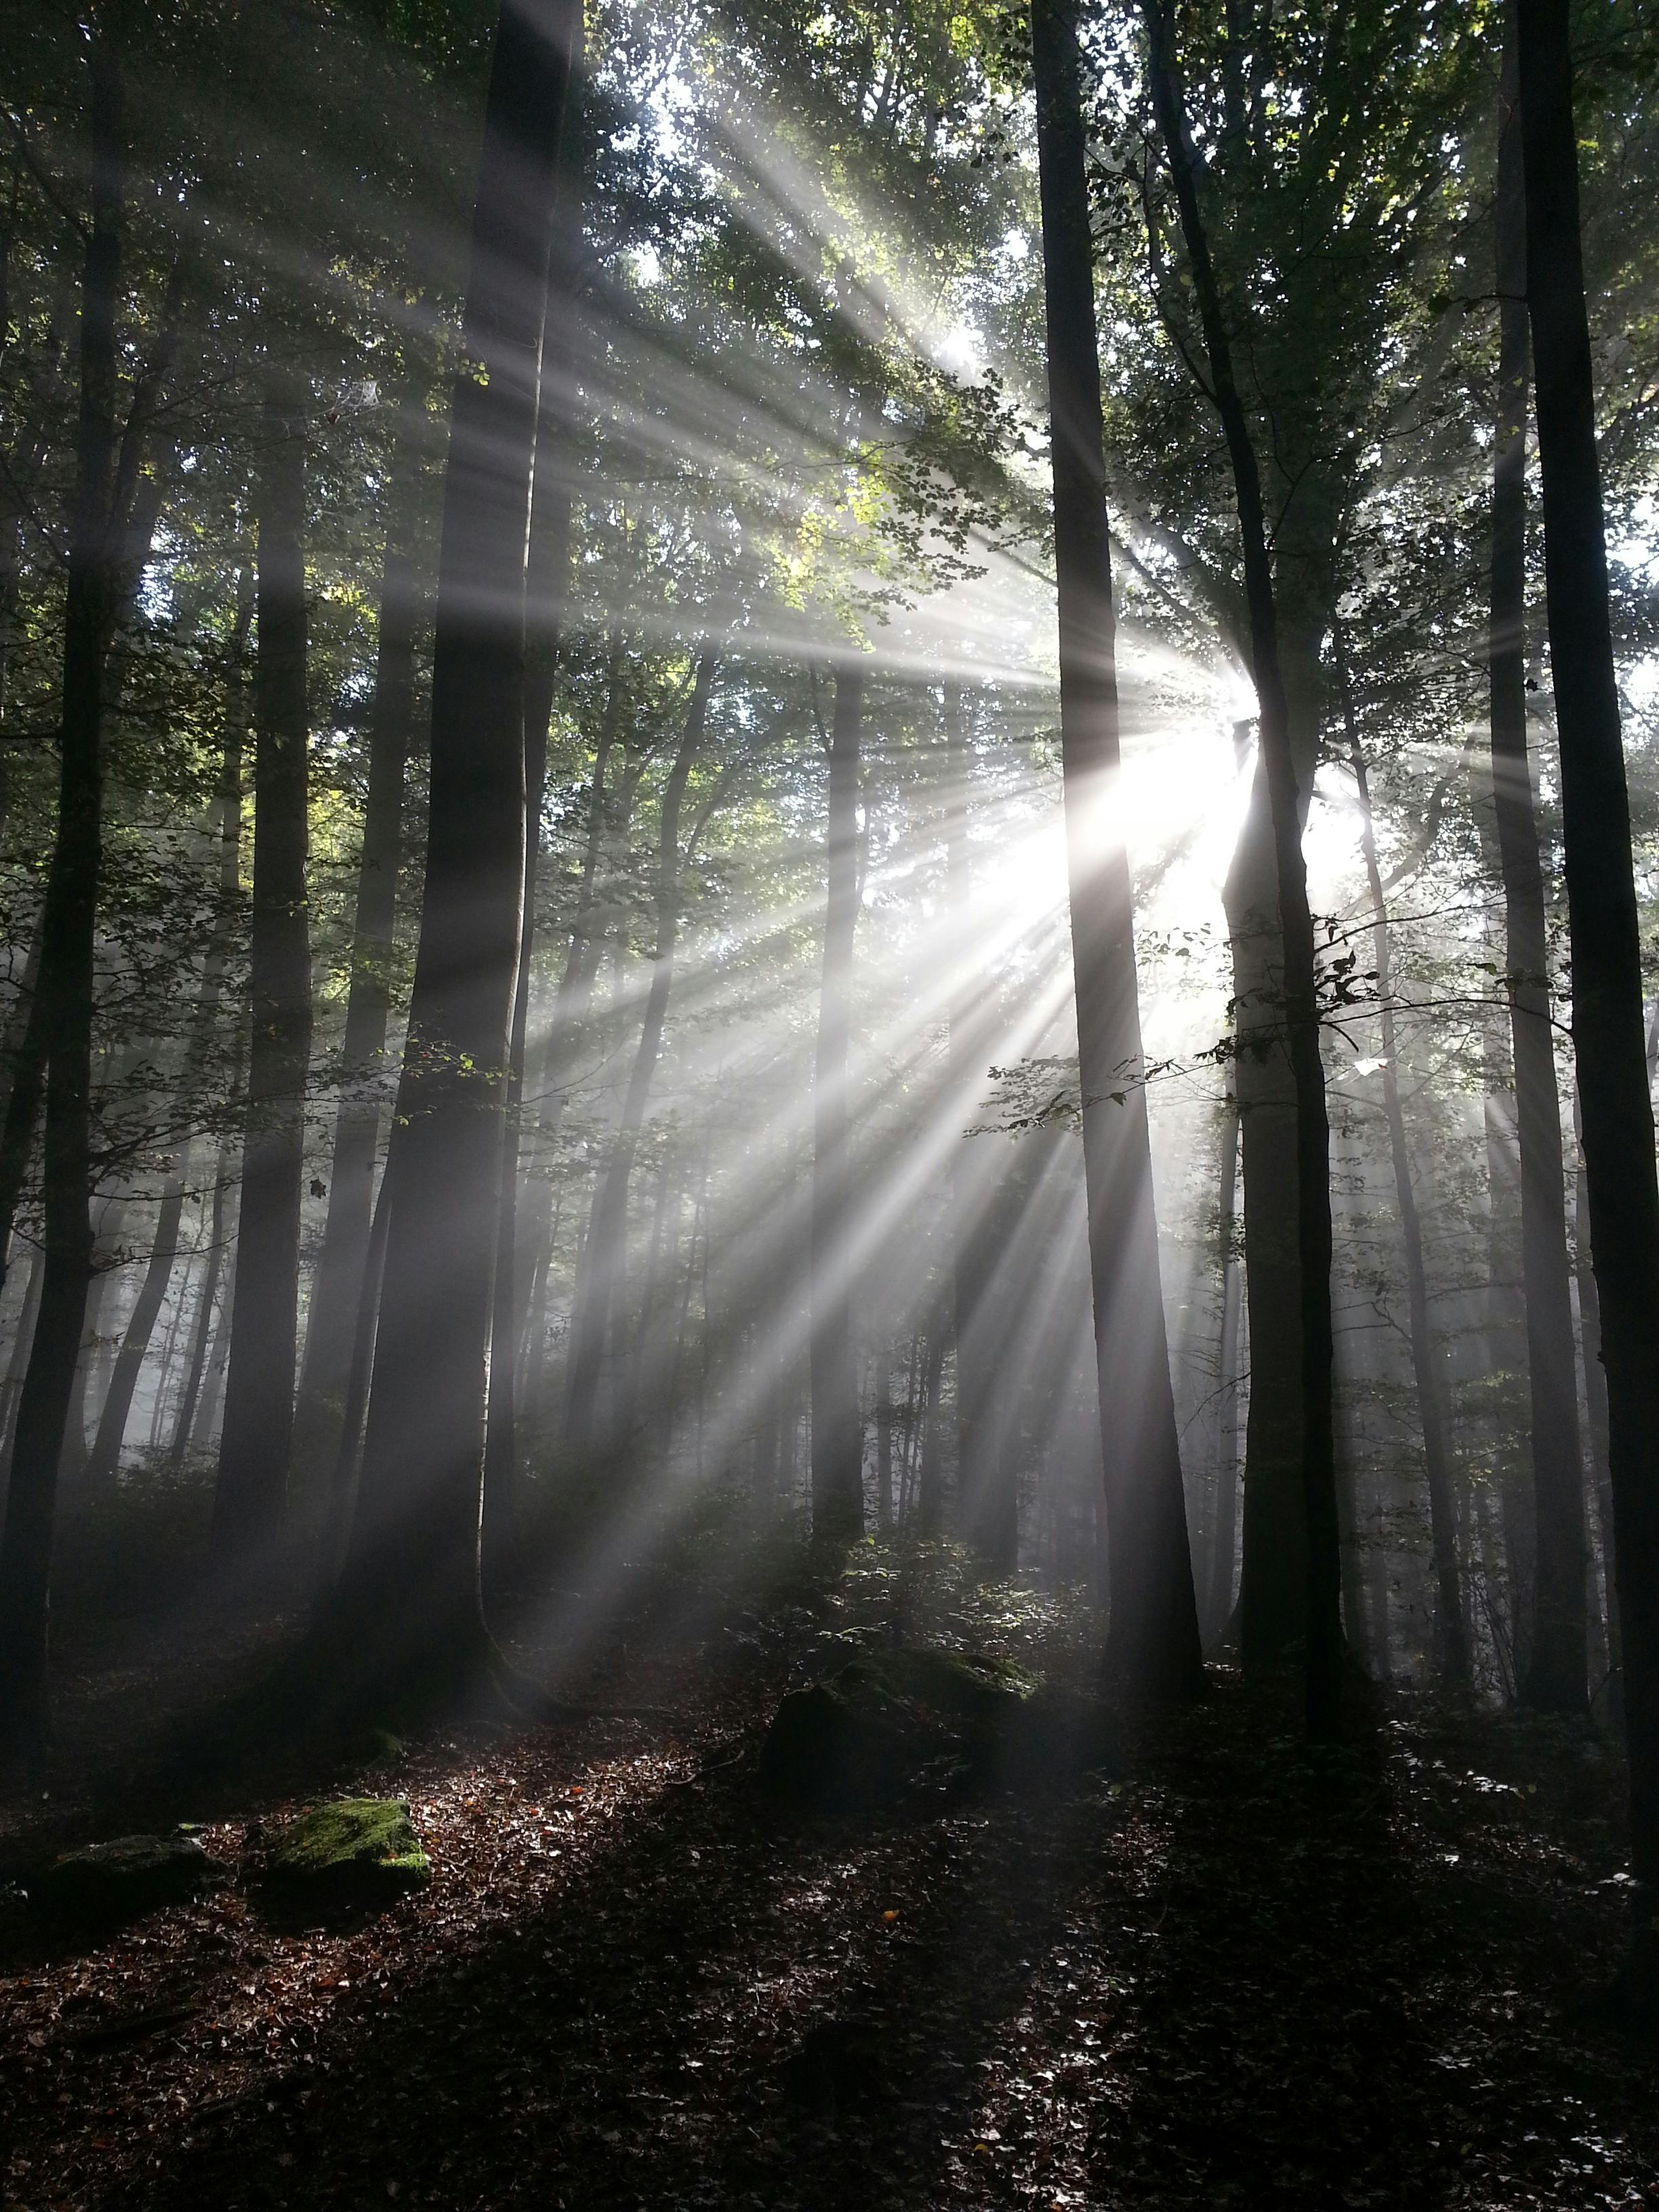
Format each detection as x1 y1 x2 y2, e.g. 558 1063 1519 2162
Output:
1146 0 1343 1741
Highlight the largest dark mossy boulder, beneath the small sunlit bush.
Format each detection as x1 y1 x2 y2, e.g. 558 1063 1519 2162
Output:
761 1643 1113 1809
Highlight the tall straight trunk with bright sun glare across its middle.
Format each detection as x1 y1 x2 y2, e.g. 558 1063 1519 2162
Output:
1031 0 1204 1694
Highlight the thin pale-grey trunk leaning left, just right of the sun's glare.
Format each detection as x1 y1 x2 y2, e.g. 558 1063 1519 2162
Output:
1336 630 1469 1685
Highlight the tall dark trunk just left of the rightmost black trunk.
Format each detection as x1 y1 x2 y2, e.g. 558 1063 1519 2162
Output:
1489 11 1586 1712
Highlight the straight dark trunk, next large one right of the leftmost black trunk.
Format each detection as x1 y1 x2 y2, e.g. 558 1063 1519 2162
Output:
212 392 312 1573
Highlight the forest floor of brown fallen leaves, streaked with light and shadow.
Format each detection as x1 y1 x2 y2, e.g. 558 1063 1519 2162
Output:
0 1530 1659 2212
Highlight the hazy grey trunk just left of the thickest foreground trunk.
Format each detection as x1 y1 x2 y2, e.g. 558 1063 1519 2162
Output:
294 403 425 1517
